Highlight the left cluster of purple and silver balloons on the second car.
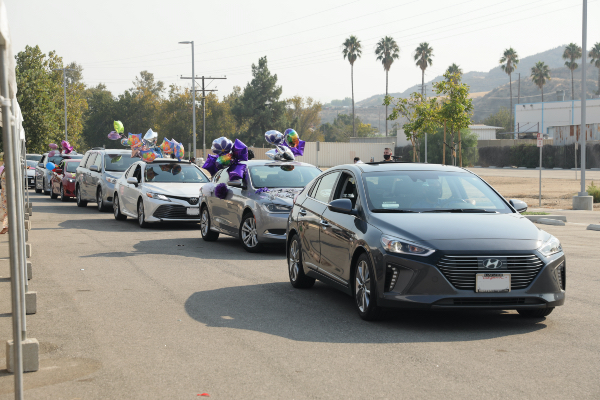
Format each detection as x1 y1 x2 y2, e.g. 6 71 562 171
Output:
202 136 248 181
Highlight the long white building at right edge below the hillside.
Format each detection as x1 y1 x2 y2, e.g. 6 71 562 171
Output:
514 99 600 134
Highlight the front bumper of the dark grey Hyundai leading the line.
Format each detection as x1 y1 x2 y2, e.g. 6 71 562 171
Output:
377 252 566 310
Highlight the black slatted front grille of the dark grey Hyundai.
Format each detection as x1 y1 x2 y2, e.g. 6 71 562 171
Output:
437 255 544 290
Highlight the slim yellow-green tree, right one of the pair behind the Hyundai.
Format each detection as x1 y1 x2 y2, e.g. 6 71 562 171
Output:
433 73 473 166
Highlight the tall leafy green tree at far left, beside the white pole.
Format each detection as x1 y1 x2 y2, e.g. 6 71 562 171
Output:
15 46 64 153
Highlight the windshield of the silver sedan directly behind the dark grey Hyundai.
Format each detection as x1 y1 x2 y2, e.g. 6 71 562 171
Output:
250 165 321 188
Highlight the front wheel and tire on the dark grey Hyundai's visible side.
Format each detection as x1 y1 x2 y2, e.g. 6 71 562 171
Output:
352 253 383 321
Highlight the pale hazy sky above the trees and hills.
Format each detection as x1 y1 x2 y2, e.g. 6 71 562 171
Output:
5 0 600 102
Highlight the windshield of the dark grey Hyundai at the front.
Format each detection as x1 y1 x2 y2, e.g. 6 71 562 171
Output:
363 171 512 213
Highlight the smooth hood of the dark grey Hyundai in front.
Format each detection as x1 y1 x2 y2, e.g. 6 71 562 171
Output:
372 213 548 250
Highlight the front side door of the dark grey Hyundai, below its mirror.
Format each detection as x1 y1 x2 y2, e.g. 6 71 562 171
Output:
320 171 358 282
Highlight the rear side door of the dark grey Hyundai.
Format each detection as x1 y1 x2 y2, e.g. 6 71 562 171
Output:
298 171 340 269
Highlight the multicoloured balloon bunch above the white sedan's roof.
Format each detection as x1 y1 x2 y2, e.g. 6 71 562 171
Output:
108 121 185 162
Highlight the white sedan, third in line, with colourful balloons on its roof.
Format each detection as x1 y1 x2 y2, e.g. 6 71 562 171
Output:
113 158 210 228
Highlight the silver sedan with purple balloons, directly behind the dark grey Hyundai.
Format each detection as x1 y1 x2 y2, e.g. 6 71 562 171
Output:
200 160 321 252
